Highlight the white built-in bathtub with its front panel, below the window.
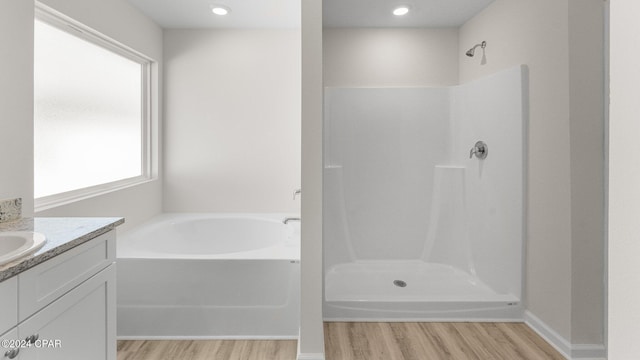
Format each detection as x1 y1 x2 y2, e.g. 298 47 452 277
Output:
116 214 300 339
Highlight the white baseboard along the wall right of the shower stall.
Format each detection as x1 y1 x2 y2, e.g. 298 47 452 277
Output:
524 311 606 360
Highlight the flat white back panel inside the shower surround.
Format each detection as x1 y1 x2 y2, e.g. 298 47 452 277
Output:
324 88 450 263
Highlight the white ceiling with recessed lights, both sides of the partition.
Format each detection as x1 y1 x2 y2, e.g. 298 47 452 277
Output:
128 0 494 29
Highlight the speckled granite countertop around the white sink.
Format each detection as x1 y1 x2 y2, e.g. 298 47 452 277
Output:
0 217 124 281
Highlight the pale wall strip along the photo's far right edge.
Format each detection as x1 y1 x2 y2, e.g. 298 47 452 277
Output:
608 0 640 360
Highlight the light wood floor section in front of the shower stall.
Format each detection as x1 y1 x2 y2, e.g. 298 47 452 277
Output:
325 323 564 360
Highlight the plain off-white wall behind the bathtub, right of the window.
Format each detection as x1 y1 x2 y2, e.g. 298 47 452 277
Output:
164 29 301 213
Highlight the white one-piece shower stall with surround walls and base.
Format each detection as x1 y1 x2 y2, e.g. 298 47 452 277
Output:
323 66 527 321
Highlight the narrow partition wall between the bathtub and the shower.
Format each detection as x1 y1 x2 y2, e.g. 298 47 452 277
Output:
297 0 324 360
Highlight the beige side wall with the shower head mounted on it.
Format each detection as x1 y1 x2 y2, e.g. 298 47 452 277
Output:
459 0 571 339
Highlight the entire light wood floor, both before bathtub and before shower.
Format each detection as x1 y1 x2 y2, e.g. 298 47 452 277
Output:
118 322 564 360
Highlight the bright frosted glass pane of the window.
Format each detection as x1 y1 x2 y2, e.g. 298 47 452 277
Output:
34 21 143 198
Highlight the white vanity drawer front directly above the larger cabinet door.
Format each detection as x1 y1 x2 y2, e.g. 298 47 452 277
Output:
18 231 116 321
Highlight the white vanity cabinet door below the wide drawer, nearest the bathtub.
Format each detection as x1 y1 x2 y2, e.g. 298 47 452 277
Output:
18 265 116 360
